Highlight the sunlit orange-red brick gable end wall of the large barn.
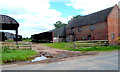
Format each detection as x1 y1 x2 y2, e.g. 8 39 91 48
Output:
107 5 120 45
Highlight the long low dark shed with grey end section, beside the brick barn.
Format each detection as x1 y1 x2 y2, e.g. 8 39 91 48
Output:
31 27 66 42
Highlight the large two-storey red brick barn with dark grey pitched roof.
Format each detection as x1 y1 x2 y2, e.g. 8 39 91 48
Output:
66 5 120 45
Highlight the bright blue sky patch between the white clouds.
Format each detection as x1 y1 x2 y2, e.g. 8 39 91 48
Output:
50 2 84 17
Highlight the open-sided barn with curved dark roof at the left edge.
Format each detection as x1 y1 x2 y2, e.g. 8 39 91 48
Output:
0 14 21 42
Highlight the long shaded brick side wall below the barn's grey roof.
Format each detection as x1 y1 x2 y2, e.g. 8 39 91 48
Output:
66 22 108 40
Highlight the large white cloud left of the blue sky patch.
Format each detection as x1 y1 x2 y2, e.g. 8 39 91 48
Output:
0 0 68 37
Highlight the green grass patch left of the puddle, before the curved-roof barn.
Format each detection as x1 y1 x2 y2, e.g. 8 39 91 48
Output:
2 47 37 63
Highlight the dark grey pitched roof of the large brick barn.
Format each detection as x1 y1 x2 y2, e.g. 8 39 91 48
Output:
67 7 113 28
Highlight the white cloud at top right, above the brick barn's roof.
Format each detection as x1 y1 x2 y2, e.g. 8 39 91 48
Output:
66 0 120 14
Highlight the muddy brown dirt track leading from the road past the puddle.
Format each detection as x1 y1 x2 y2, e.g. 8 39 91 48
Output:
2 44 116 64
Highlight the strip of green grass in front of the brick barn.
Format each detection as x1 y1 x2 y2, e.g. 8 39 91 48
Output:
44 43 120 51
